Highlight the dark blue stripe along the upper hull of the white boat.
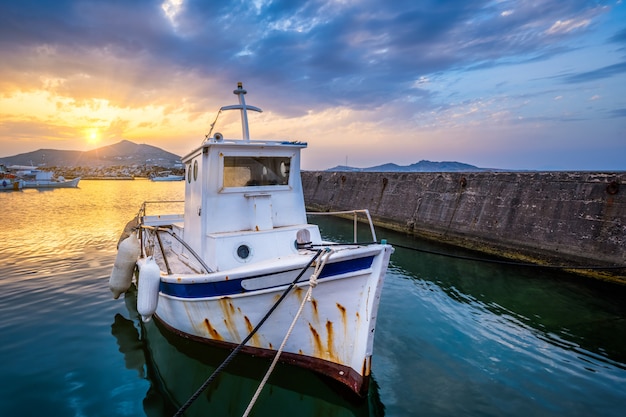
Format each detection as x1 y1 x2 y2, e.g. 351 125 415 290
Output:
159 256 374 298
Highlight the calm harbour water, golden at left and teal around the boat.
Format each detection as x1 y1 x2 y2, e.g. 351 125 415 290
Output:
0 180 626 417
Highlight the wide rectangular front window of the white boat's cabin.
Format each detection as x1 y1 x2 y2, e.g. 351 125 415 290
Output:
224 156 291 187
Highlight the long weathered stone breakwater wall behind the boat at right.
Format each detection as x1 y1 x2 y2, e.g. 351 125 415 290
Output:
302 171 626 284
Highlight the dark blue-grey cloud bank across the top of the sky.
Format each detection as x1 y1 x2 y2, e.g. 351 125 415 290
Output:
0 0 598 114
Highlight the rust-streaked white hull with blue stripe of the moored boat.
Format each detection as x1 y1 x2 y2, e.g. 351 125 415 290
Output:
138 245 392 395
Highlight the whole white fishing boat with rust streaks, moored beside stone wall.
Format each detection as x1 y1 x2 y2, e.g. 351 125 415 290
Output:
110 83 393 395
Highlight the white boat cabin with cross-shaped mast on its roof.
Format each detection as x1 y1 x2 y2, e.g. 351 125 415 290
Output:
173 84 320 271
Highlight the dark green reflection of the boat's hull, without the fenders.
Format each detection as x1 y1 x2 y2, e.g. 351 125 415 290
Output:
129 308 383 417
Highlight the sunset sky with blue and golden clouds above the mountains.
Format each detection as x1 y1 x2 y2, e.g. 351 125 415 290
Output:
0 0 626 171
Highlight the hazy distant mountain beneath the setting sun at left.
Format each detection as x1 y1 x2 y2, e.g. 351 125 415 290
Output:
0 140 182 168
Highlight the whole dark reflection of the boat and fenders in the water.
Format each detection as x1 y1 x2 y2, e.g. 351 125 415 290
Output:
111 286 384 417
